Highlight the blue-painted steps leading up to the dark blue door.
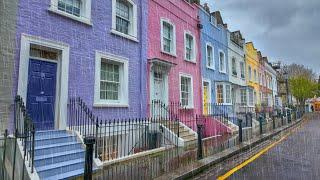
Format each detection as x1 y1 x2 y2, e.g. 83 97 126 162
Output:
34 130 85 180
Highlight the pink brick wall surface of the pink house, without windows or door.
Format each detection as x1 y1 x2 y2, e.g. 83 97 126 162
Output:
147 0 201 113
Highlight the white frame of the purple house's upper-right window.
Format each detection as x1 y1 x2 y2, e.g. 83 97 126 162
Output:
110 0 139 42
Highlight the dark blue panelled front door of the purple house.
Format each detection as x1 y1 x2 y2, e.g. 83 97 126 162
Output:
27 59 57 130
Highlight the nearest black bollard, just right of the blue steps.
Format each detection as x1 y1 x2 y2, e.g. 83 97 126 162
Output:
84 136 96 180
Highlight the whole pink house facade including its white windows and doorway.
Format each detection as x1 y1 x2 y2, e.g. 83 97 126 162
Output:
147 0 202 114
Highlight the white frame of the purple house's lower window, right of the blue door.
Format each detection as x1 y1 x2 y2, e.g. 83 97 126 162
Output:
93 51 129 107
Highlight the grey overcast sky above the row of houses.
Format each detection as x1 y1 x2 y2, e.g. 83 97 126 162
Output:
202 0 320 74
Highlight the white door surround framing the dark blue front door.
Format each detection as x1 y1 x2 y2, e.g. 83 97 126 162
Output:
17 34 69 129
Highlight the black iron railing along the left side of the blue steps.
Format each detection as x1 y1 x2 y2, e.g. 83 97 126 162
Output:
12 95 35 175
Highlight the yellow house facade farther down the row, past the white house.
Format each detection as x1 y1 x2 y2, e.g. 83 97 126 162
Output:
245 42 260 106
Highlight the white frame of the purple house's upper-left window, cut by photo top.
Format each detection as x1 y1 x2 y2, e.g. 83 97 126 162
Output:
48 0 92 26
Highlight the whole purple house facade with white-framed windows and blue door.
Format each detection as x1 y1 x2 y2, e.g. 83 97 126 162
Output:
10 0 148 129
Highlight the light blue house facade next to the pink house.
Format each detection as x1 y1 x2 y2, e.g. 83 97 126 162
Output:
199 6 232 114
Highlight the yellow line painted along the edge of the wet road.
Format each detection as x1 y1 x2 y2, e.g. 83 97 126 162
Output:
217 121 306 180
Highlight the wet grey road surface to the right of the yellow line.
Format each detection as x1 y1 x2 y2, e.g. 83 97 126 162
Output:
229 118 320 180
